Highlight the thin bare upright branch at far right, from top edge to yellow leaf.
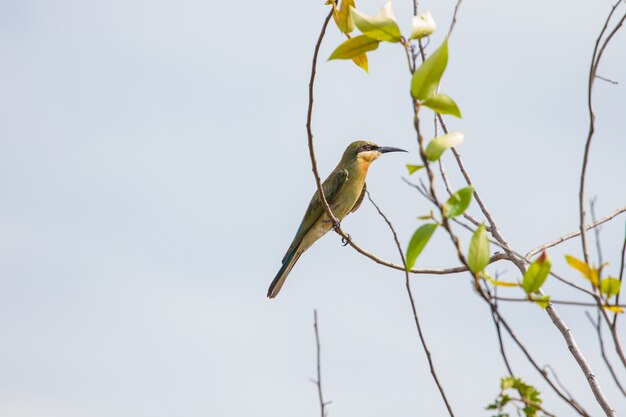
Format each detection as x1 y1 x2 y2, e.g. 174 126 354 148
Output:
578 0 626 264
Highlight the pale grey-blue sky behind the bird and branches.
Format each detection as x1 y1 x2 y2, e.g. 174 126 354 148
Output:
0 0 626 417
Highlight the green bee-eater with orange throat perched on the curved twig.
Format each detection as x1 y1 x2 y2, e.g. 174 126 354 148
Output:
267 141 406 298
